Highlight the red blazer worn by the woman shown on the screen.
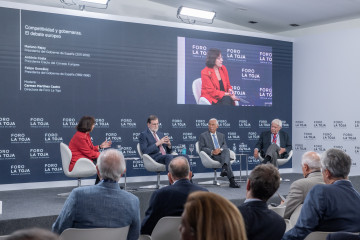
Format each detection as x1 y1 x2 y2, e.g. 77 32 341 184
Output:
201 65 232 103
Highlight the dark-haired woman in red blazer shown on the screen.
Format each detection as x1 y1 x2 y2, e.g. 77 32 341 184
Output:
201 48 239 105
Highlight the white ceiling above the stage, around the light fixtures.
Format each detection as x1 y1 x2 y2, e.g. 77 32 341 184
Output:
4 0 360 33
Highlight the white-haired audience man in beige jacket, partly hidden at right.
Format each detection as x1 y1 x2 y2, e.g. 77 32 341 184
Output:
281 152 324 219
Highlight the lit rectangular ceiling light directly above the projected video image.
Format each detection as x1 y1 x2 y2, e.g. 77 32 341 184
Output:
176 6 216 24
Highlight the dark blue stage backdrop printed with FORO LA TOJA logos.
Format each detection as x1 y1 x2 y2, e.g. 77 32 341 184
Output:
0 8 292 184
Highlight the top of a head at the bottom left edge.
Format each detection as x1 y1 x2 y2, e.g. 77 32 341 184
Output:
5 228 59 240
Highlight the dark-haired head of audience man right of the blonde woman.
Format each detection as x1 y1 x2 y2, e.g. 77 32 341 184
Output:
246 164 280 201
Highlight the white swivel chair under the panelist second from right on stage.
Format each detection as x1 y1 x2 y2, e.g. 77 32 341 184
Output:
195 142 236 186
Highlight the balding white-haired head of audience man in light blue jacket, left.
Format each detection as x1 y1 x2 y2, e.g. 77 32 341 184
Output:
97 149 126 182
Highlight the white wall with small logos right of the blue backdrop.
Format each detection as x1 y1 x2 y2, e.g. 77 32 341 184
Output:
280 19 360 175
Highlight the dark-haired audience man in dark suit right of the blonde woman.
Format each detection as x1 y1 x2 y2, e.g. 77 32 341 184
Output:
239 164 286 240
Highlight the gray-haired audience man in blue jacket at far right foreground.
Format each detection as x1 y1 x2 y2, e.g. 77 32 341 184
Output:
282 148 360 240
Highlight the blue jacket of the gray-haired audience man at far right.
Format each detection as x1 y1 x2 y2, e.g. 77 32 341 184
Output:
282 180 360 240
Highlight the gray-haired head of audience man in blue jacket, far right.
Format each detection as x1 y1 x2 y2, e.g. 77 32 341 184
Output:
320 148 351 180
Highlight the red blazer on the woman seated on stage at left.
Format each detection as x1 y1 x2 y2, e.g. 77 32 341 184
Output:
69 131 100 172
